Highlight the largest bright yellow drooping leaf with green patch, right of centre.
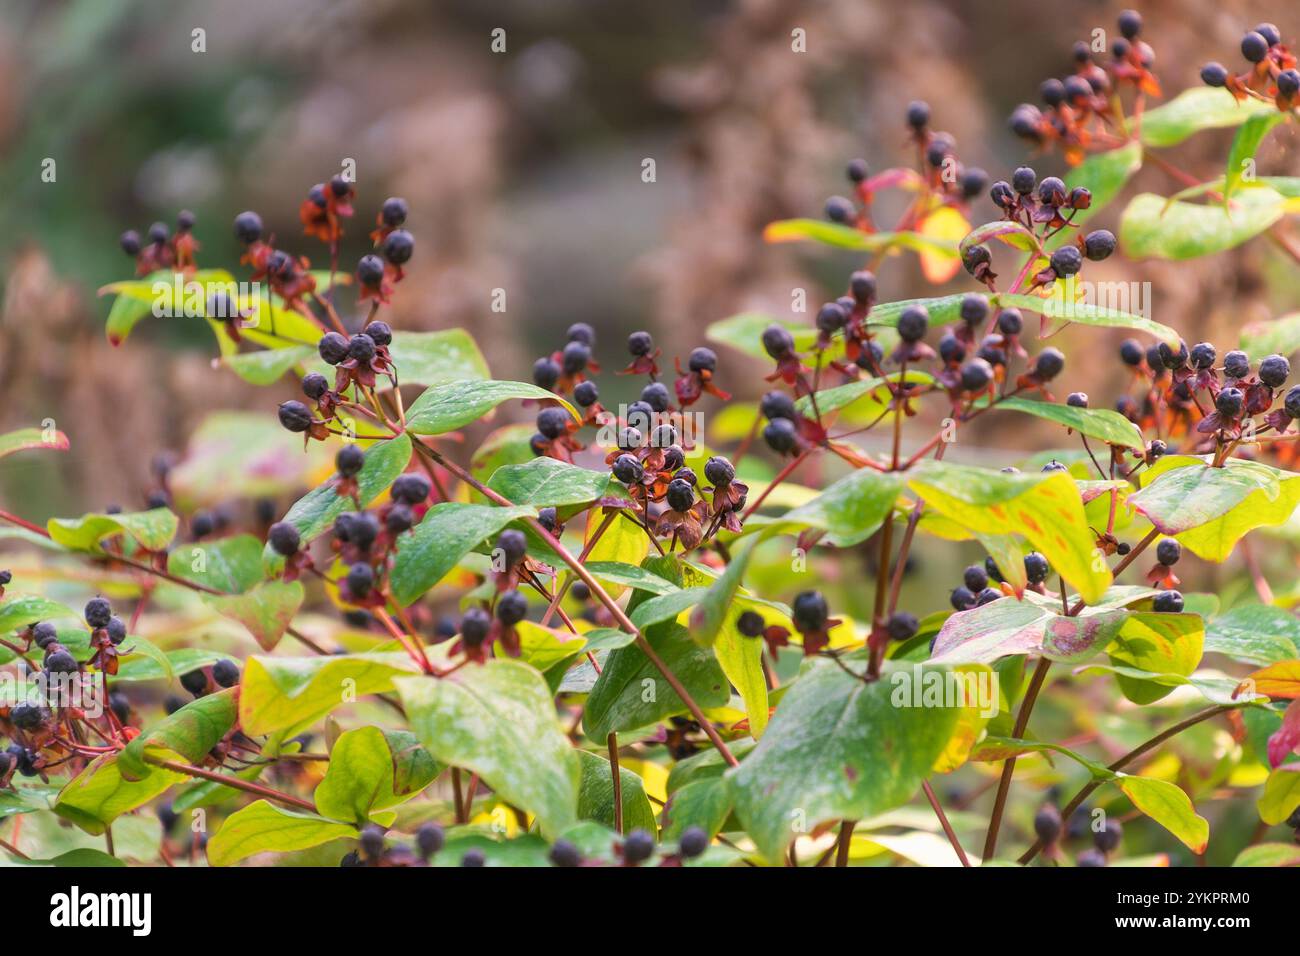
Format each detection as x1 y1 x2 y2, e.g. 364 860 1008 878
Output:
907 462 1110 604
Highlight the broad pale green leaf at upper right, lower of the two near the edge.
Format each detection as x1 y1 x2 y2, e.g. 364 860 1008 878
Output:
1119 185 1288 259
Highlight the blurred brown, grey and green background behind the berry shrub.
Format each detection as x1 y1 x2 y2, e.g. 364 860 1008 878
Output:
0 0 1300 520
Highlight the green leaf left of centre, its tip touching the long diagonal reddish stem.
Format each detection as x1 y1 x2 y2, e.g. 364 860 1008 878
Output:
389 501 537 606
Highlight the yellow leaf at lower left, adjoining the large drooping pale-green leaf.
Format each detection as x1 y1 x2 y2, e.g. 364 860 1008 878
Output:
239 652 415 736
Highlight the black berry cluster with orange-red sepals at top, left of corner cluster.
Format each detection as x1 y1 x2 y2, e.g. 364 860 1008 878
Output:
1009 10 1160 165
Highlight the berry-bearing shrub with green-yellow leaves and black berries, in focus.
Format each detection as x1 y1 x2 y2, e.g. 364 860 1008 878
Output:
0 12 1300 866
